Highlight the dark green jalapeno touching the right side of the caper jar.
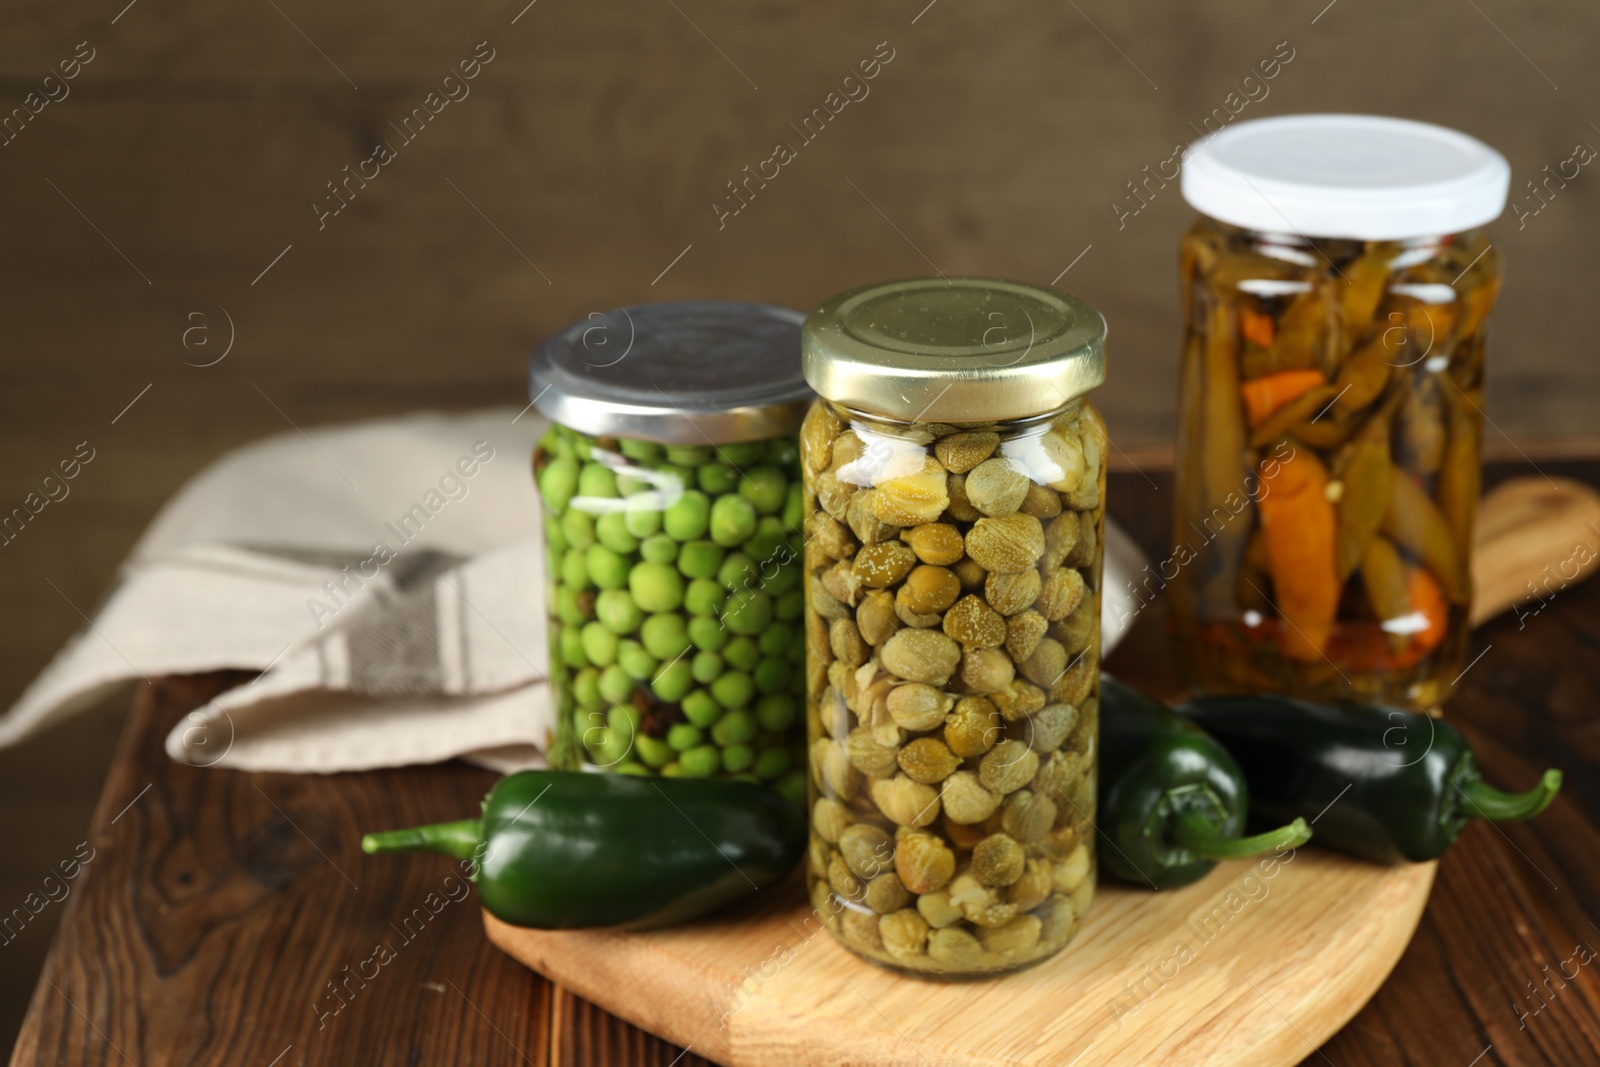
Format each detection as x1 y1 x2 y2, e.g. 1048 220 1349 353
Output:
1099 675 1310 889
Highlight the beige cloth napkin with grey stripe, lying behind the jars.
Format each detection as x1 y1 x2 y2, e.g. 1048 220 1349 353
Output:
0 408 1144 771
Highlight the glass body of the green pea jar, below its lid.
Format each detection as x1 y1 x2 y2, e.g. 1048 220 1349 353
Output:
533 426 805 801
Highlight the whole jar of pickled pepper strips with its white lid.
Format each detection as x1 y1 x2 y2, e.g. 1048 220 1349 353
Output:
1158 115 1509 709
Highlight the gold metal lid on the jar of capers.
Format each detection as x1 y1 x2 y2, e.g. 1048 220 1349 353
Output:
800 278 1106 422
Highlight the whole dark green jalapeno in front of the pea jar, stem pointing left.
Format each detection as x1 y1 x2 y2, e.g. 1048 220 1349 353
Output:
362 771 806 929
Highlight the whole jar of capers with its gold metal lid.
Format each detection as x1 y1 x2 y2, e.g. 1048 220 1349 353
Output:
800 278 1107 976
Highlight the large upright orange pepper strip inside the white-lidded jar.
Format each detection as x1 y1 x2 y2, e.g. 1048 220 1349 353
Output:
1258 450 1339 659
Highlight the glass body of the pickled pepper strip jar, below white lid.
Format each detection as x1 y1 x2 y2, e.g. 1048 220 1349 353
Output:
1157 218 1501 709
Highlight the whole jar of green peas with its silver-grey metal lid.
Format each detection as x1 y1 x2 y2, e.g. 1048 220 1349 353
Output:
530 301 811 803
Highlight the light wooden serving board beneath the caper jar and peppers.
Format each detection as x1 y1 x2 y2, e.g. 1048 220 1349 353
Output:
483 849 1435 1067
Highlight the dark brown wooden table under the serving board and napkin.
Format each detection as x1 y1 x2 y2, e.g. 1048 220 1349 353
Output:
11 461 1600 1067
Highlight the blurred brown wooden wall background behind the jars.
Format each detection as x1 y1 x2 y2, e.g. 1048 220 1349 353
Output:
0 0 1600 1048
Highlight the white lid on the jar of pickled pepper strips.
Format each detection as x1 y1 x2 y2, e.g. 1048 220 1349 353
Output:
1182 115 1510 240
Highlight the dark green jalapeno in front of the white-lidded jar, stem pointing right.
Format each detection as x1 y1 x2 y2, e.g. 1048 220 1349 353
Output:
1179 696 1562 864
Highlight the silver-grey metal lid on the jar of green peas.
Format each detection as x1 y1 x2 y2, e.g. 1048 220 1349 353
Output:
528 301 811 445
